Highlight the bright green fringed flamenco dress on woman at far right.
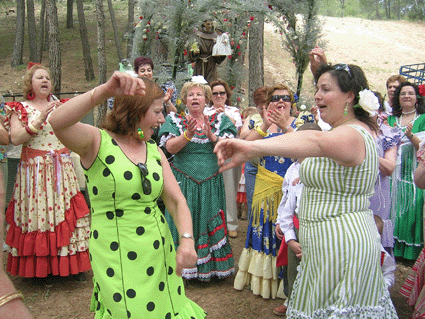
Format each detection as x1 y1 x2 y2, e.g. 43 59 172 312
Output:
388 114 425 259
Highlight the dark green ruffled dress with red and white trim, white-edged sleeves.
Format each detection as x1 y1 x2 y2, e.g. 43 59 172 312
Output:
159 113 236 281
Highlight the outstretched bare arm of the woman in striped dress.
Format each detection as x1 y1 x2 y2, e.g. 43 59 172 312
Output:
214 126 366 171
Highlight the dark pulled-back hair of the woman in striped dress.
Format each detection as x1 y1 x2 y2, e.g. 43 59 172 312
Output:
314 64 378 131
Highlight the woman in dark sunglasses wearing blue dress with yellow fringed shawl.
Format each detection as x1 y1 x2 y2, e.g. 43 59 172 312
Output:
233 84 295 299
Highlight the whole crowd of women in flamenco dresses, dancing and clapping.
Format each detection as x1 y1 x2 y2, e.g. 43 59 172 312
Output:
0 48 425 318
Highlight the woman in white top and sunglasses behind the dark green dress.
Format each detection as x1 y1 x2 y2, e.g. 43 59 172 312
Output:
204 80 242 238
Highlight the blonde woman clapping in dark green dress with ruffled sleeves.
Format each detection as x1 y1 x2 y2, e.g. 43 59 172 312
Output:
159 82 236 281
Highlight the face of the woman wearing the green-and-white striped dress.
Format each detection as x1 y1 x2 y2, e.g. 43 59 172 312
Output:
314 72 353 126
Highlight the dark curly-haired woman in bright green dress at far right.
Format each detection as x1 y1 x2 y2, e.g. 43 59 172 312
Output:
388 82 425 260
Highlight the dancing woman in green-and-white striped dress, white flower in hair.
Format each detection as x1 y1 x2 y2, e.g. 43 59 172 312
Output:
215 64 397 318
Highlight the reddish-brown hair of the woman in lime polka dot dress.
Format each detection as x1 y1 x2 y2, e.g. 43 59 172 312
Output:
102 78 164 137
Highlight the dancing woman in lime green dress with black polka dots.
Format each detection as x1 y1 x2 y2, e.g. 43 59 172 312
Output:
50 72 205 319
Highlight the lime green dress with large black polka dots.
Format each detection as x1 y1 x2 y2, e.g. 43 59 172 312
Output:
86 130 205 319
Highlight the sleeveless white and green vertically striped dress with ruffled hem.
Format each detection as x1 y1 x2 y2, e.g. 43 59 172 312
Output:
287 125 397 318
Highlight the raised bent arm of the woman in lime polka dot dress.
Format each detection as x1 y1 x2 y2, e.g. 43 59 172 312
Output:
49 72 145 167
